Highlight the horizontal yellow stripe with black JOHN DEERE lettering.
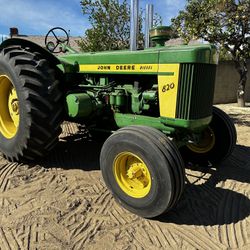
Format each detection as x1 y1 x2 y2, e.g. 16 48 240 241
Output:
80 64 158 73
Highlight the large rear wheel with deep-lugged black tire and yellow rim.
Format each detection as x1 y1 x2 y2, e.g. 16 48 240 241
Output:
0 45 63 161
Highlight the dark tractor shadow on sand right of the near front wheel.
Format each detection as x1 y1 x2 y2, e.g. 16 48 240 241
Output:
156 145 250 226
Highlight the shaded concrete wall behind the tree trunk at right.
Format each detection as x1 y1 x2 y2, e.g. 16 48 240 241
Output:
214 61 250 104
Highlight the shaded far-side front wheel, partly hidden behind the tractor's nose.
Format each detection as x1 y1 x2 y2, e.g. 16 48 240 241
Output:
180 107 237 165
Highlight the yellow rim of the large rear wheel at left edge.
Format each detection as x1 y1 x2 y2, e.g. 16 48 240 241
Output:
0 75 19 139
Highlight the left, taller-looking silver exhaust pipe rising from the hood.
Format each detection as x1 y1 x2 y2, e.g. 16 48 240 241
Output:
130 0 139 51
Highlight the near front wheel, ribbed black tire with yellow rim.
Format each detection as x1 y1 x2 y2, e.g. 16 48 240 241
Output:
100 126 184 218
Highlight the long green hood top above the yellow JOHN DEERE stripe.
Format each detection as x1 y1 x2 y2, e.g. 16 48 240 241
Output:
59 44 216 74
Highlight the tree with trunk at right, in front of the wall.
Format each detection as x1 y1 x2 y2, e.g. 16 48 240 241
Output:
172 0 250 106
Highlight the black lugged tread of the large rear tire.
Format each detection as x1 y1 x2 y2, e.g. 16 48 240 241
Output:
0 46 63 161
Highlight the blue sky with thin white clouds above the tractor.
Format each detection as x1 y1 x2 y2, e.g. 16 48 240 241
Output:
0 0 186 36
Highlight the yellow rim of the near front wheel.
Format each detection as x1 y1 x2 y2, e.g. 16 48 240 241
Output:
113 152 151 198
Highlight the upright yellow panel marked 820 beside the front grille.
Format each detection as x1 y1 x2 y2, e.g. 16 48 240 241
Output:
158 64 180 118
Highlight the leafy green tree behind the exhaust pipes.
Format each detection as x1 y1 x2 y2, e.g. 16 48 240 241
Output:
80 0 143 51
